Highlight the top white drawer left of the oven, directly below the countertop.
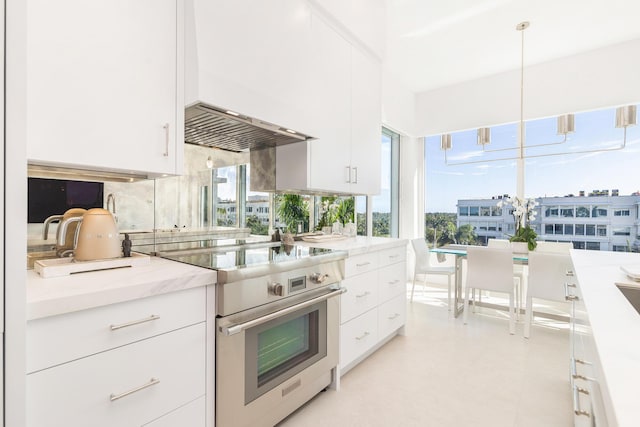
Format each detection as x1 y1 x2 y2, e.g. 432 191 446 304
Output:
26 287 206 372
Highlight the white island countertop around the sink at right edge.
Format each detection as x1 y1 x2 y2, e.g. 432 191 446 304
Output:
571 250 640 426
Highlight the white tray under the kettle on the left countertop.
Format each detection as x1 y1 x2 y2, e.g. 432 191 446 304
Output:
33 252 151 278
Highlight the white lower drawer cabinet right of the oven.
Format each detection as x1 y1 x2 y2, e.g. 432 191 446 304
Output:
340 246 407 374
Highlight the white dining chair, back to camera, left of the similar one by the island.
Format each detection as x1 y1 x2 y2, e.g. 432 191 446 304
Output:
463 246 516 335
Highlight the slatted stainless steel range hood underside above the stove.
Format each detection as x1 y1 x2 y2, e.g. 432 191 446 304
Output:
184 103 313 152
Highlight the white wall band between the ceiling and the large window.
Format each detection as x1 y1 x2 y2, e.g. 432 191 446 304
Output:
416 39 640 136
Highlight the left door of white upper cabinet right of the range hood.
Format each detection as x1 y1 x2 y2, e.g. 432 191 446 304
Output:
307 15 351 192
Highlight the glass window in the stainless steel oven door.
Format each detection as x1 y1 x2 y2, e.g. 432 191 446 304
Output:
244 301 327 404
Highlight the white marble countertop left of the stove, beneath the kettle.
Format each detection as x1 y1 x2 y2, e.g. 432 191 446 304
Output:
26 257 217 320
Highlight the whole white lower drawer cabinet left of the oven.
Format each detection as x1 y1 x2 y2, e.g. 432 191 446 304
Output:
26 288 207 427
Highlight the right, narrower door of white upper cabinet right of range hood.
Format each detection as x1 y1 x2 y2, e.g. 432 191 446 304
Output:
351 47 382 194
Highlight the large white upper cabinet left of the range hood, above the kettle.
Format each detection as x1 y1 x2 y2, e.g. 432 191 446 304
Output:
27 0 184 176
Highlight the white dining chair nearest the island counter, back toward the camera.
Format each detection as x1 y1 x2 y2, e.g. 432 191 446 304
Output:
524 251 573 338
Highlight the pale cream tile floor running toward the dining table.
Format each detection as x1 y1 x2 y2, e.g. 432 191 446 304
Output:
279 287 573 427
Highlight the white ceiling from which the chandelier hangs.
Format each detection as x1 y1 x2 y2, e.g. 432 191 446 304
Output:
385 0 640 92
